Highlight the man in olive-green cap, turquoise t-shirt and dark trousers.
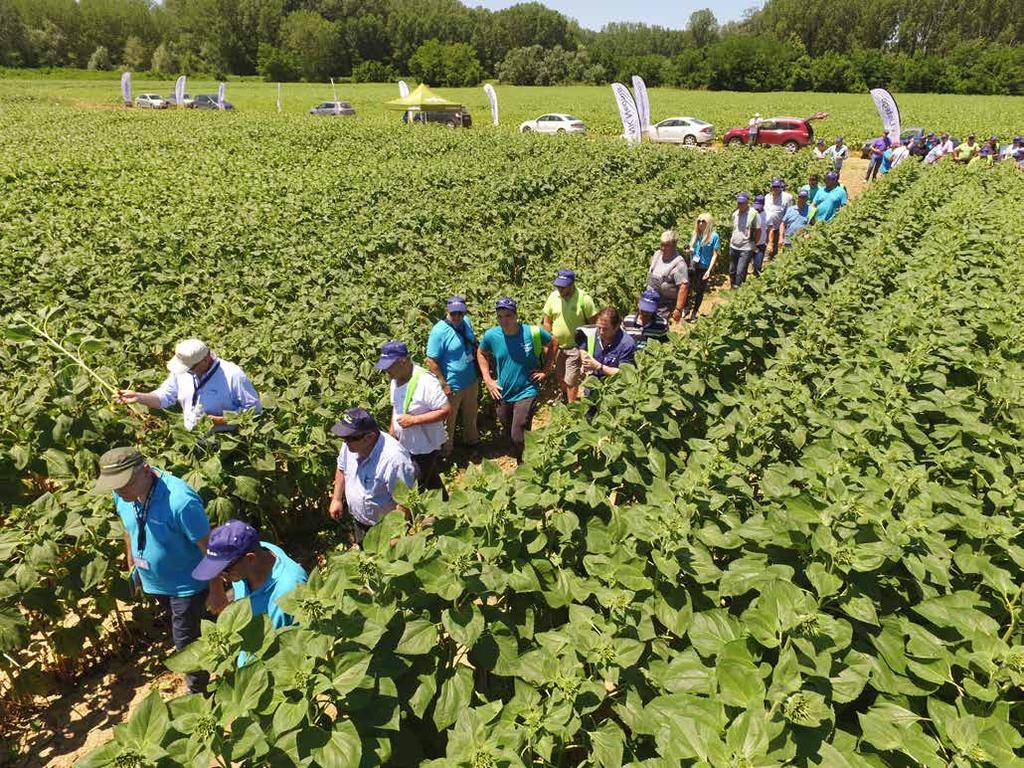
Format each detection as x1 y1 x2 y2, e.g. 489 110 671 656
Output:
93 447 218 693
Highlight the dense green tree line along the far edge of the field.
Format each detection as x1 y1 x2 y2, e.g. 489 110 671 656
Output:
0 0 1024 94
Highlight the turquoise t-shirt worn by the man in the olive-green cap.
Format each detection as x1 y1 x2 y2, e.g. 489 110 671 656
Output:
114 470 210 597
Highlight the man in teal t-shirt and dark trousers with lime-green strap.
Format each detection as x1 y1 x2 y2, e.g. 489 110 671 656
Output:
476 296 557 462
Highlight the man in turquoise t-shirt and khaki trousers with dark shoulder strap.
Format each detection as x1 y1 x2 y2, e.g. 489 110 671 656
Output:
427 296 480 455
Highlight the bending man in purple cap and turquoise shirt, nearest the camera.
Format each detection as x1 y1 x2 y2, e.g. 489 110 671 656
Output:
191 520 306 629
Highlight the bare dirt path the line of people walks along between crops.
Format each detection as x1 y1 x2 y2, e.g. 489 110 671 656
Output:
6 158 867 768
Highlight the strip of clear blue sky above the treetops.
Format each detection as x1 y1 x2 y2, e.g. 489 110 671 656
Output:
463 0 762 30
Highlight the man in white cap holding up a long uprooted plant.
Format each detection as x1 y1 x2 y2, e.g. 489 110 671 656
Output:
116 339 263 429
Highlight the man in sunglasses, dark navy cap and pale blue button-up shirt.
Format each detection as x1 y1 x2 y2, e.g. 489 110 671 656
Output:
328 408 416 544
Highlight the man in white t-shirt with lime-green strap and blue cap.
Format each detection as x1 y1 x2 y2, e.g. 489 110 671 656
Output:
375 341 452 488
